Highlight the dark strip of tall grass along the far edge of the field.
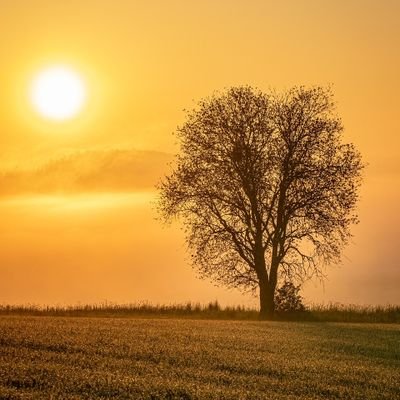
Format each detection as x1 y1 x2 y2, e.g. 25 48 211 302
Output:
0 301 400 323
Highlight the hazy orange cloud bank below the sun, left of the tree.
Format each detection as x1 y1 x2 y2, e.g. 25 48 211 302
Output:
0 149 173 197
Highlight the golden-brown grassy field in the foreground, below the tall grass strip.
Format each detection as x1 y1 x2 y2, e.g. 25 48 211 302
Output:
0 316 400 400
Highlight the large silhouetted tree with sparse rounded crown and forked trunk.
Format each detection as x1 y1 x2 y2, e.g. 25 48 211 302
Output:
158 86 363 318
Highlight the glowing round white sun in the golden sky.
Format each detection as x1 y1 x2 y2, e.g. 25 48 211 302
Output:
30 66 86 121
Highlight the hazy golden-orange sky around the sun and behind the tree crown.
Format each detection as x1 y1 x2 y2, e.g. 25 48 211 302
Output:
0 0 400 304
